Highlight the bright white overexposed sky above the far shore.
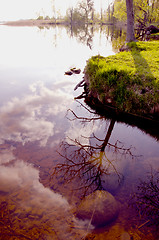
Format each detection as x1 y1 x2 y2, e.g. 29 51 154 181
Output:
0 0 112 21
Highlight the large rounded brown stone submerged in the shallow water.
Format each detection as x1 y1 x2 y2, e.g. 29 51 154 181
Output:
76 190 119 227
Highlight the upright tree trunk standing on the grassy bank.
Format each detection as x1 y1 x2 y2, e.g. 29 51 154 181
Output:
126 0 136 42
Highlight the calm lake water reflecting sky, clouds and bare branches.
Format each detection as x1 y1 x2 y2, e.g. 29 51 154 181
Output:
0 23 159 240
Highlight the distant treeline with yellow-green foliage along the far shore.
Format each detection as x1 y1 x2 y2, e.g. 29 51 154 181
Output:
37 0 159 26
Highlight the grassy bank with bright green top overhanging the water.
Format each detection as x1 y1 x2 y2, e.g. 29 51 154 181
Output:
85 41 159 118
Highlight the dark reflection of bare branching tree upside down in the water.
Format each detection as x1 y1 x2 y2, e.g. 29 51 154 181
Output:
53 100 133 195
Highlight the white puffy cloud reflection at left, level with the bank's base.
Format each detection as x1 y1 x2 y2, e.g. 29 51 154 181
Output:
0 83 70 146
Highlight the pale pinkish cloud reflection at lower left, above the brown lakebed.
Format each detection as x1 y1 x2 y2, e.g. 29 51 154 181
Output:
0 159 69 209
